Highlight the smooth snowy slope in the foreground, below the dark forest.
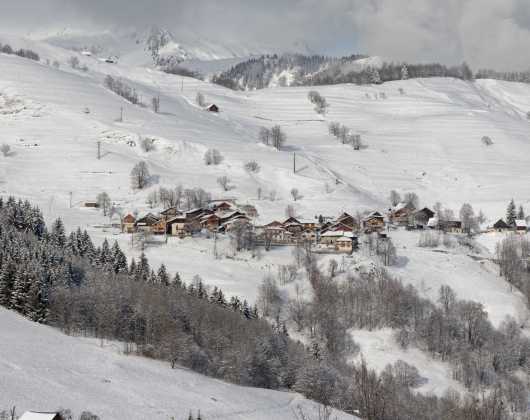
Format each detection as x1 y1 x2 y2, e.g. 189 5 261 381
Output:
0 308 354 420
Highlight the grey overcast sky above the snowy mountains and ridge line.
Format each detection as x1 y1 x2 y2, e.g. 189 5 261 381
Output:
0 0 530 69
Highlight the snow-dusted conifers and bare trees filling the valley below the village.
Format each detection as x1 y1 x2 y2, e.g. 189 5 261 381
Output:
0 198 530 420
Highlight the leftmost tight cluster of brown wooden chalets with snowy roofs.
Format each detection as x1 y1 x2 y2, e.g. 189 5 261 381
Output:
122 200 257 238
